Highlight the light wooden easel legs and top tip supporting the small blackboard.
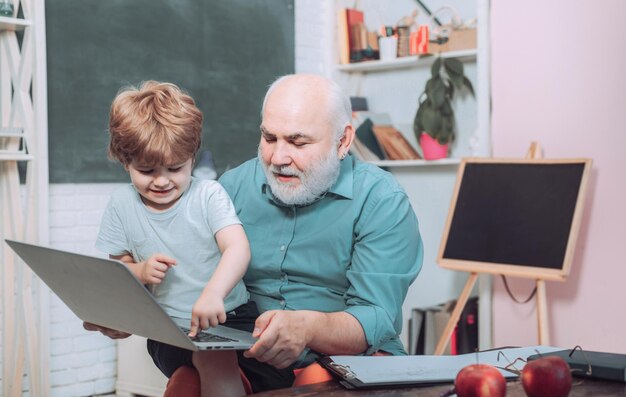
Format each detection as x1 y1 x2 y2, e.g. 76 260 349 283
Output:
435 142 550 355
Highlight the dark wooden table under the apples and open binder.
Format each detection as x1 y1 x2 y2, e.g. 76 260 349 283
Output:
254 378 626 397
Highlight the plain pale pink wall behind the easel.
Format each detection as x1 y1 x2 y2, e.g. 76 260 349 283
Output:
491 0 626 353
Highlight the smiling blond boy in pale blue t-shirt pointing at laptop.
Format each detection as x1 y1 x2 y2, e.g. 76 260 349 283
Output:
96 81 250 396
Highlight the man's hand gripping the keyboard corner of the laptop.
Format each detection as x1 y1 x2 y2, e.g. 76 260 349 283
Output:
243 310 312 369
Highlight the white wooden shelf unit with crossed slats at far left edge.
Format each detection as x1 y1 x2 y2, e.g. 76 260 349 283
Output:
0 0 50 397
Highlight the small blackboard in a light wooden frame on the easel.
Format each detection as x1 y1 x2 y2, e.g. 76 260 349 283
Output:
438 159 591 281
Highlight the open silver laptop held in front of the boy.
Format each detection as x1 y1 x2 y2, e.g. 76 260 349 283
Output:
5 240 256 351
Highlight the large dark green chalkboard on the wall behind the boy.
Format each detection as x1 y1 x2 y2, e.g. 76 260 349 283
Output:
46 0 295 183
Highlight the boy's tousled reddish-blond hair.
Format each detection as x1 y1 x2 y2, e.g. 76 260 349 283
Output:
109 80 202 166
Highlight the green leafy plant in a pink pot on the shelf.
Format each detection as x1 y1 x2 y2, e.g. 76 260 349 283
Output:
413 57 474 160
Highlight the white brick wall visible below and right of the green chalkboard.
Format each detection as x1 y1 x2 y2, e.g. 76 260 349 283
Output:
44 0 334 397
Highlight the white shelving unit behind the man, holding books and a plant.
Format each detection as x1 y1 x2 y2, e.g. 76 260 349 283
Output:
333 0 491 348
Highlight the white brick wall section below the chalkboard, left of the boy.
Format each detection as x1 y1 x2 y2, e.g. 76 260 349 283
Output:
50 184 121 397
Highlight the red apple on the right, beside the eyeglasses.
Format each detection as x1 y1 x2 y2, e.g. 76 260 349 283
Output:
521 356 572 397
